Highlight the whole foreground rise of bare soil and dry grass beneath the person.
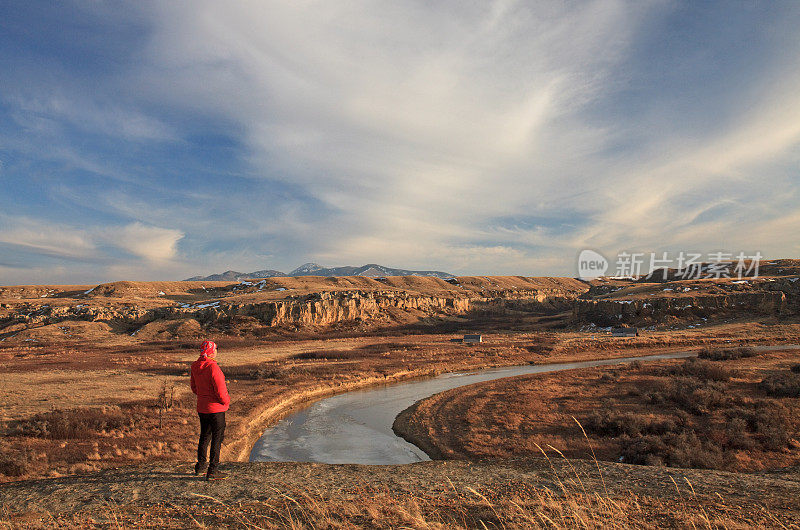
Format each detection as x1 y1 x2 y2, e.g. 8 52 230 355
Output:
0 412 800 530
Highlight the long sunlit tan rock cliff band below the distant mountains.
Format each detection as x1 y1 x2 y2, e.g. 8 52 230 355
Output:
0 277 587 341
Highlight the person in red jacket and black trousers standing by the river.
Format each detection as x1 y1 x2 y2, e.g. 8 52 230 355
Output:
191 340 231 480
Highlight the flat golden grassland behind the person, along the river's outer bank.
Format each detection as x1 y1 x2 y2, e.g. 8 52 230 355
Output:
0 323 800 482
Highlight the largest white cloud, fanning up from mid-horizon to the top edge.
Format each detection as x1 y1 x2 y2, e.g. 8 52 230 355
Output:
139 2 647 272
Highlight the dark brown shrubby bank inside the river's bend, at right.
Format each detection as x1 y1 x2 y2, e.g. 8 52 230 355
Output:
393 346 800 472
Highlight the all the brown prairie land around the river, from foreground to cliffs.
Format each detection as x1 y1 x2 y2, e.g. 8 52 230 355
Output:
0 270 800 528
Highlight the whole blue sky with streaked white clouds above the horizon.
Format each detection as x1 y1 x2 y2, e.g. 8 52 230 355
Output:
0 0 800 285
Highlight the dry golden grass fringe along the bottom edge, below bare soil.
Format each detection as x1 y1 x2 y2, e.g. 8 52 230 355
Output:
0 450 797 530
